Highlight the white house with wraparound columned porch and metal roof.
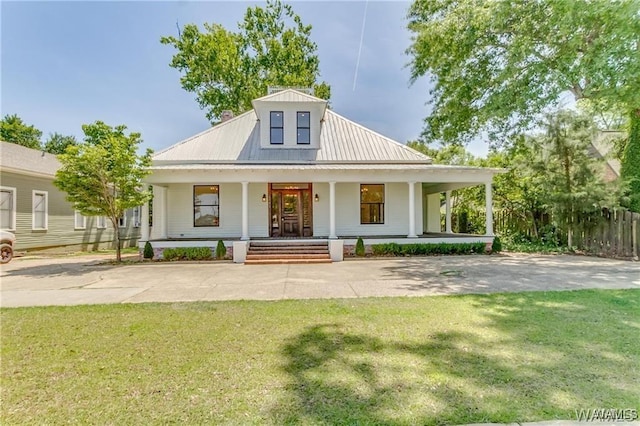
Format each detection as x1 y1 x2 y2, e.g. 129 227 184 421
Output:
141 89 499 261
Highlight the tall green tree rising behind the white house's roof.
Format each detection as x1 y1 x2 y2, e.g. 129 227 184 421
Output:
160 0 331 124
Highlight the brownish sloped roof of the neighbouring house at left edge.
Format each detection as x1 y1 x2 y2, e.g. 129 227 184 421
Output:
0 141 60 177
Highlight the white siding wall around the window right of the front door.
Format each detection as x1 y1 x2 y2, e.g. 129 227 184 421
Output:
327 182 422 237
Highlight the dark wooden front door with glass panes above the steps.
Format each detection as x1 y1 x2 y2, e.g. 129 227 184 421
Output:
269 184 312 238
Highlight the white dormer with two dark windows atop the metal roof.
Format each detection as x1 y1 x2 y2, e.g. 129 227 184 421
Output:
253 89 327 149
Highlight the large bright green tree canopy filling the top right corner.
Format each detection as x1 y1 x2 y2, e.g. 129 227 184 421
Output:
407 0 640 142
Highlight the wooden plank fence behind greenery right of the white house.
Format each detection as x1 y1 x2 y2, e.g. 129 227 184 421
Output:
494 209 640 260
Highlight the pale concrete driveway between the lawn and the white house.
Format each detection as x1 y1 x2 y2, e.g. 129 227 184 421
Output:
0 254 640 307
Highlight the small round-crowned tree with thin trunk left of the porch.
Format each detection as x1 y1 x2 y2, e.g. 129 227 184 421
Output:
54 121 151 262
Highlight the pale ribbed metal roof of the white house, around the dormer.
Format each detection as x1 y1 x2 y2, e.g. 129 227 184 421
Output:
153 108 431 165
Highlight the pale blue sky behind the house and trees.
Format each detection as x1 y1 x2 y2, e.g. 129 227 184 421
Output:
0 0 487 155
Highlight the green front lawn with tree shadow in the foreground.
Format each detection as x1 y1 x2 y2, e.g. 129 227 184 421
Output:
0 290 640 425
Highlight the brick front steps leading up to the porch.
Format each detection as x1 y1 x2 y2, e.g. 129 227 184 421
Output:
244 240 331 265
